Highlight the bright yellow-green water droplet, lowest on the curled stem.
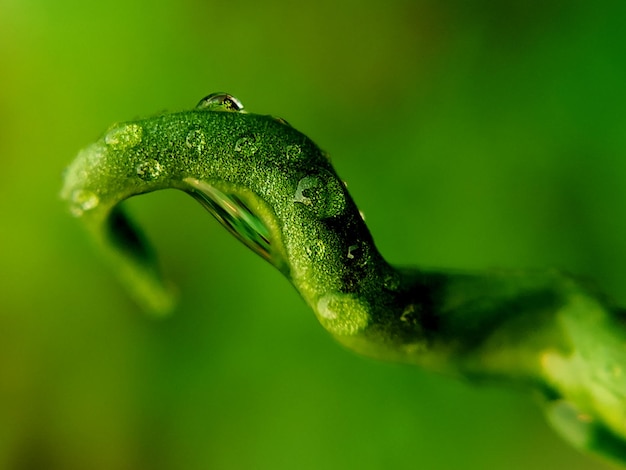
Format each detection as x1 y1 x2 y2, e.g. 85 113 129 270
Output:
317 294 369 335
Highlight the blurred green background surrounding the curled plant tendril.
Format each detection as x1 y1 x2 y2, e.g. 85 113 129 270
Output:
0 0 626 470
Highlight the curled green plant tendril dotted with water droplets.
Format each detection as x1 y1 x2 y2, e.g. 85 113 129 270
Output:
61 94 626 463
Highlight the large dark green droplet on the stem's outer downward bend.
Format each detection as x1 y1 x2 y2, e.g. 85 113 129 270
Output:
293 174 346 219
